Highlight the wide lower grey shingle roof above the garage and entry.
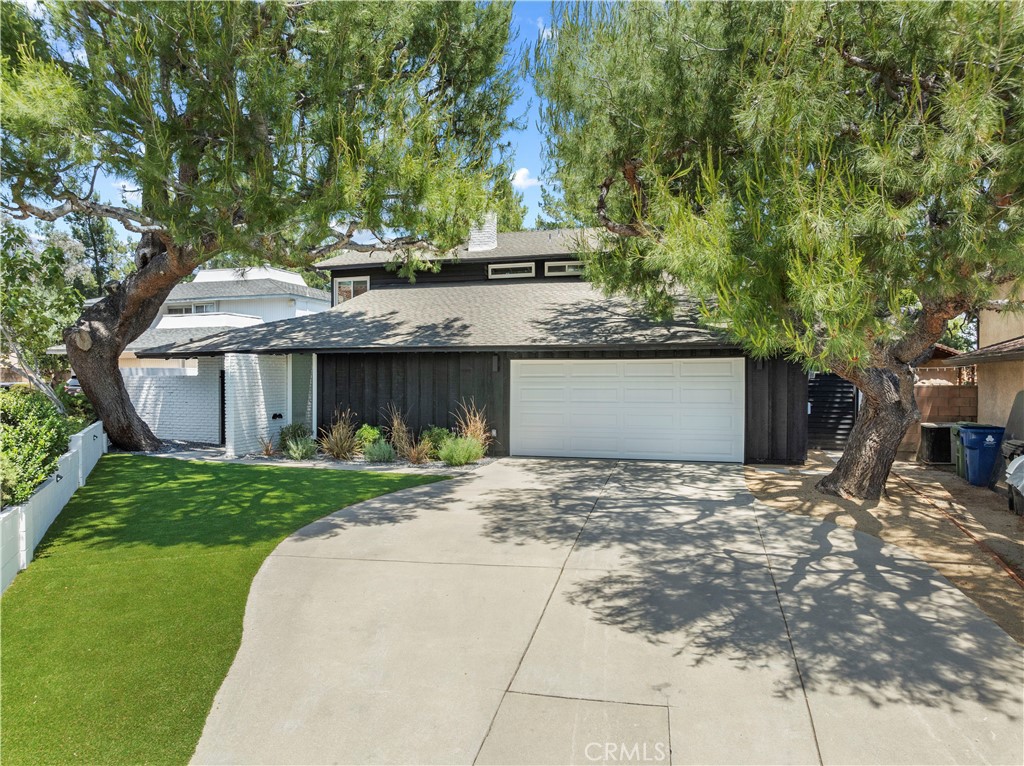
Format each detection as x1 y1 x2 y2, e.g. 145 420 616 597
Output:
139 280 734 356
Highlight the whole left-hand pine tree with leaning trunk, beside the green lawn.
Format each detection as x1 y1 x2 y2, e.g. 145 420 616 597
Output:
0 0 515 450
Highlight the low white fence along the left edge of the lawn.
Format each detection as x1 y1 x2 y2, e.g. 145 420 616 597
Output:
0 423 108 591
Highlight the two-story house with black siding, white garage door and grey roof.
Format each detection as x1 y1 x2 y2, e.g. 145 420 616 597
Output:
140 219 807 462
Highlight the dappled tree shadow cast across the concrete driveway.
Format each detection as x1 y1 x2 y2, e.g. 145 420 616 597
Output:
477 464 1024 722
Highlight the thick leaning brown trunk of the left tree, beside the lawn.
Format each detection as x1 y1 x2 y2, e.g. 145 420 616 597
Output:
65 235 197 452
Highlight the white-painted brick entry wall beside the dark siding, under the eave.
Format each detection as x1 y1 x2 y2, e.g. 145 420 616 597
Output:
224 353 288 457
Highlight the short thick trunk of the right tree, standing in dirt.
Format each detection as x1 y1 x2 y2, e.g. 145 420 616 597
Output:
817 368 921 501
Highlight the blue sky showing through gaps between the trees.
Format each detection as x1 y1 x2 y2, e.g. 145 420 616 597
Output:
58 0 551 241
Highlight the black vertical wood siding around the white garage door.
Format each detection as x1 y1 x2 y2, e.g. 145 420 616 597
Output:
316 349 807 463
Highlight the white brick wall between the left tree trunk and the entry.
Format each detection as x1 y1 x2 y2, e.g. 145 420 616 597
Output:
125 357 222 444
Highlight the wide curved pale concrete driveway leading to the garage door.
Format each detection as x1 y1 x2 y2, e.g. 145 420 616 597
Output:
195 459 1024 764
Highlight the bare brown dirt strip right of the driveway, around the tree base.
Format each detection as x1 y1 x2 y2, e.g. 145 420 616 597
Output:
745 453 1024 643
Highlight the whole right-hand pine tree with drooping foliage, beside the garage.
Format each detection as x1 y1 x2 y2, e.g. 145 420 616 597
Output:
537 2 1024 499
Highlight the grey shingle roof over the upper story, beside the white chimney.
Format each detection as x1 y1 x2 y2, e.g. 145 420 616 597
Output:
315 228 601 269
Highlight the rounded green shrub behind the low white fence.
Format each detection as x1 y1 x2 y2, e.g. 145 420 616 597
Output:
0 386 72 505
